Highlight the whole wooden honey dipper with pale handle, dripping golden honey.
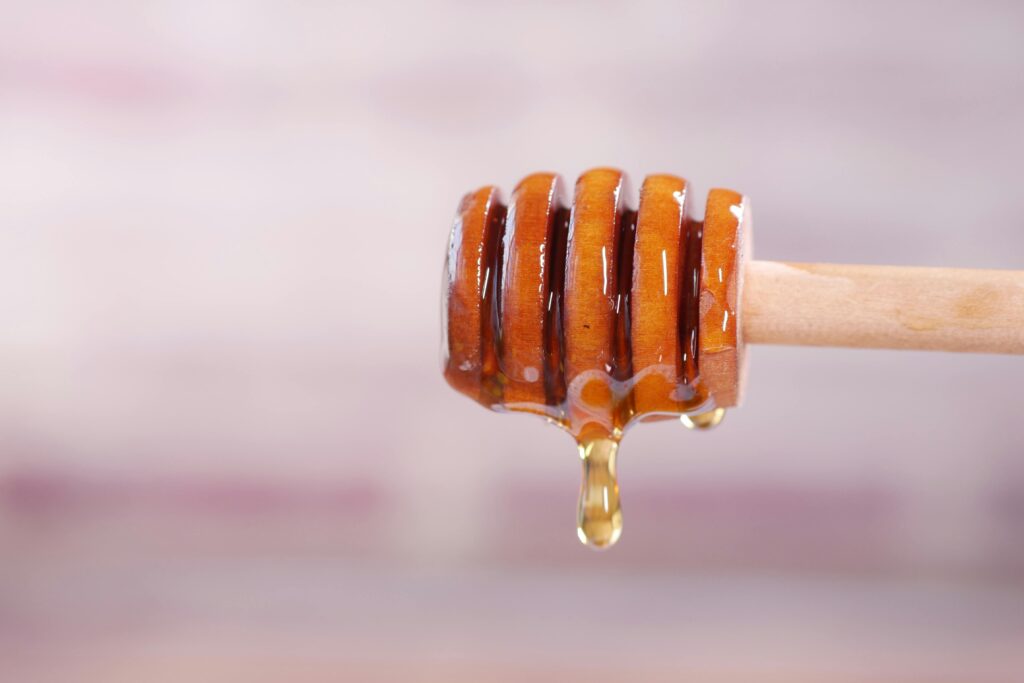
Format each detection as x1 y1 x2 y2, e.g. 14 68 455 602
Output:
443 168 1024 548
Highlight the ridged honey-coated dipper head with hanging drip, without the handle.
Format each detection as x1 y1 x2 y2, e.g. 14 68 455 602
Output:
443 168 749 548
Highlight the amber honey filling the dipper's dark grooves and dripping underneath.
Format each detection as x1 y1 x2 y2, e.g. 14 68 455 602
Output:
444 184 724 549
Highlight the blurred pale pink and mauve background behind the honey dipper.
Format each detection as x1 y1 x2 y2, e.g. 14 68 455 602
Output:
0 0 1024 683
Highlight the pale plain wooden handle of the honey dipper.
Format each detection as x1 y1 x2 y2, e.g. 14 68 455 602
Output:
742 261 1024 353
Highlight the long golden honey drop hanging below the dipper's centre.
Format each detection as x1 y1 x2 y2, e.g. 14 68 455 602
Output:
577 438 623 549
